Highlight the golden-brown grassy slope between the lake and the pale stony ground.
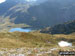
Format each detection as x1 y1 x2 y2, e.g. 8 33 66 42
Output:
0 32 75 48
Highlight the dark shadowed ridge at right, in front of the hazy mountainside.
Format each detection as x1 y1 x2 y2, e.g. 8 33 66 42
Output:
40 21 75 34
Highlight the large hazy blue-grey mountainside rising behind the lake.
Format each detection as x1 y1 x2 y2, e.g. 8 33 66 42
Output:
0 0 75 28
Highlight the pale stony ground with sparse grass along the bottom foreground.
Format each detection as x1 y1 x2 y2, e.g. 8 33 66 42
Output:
0 47 75 56
